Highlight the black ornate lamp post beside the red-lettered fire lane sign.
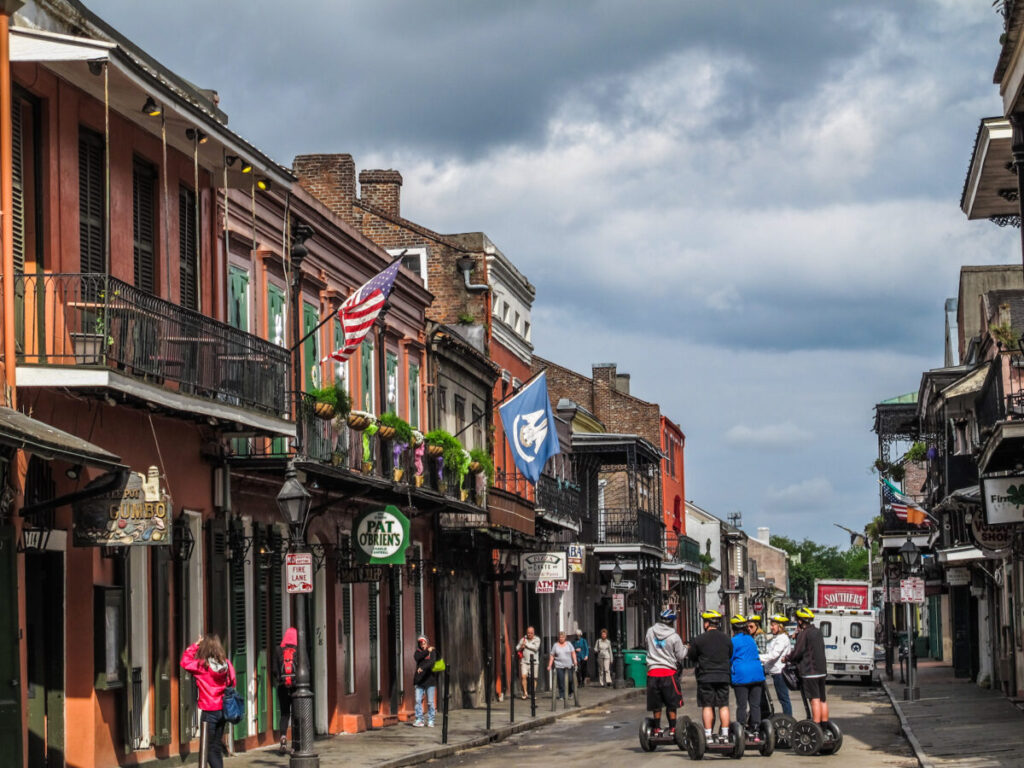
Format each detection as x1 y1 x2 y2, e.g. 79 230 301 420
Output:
278 462 319 768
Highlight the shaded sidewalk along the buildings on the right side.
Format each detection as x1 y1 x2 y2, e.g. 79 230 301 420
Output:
882 662 1024 768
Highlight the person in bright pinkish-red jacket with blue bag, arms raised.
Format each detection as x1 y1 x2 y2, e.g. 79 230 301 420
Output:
181 635 236 768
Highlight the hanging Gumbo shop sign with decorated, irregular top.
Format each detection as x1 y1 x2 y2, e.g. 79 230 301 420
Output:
72 467 171 547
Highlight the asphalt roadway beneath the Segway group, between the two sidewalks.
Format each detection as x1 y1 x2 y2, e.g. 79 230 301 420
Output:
438 682 918 768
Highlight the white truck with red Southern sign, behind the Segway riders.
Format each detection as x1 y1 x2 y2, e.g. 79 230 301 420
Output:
814 579 876 682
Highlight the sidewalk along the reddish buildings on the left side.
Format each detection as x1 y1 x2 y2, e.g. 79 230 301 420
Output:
226 685 643 768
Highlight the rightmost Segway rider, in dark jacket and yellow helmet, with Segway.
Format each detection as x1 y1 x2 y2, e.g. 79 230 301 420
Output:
786 607 843 755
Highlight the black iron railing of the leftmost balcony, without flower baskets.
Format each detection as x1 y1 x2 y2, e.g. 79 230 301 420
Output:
14 273 289 416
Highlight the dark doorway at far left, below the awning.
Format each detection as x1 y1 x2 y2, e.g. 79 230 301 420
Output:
25 552 65 768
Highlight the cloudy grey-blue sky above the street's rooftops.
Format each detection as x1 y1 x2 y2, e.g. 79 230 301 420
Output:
85 0 1021 544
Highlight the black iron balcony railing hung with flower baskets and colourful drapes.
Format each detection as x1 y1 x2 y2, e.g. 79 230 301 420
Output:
231 392 487 507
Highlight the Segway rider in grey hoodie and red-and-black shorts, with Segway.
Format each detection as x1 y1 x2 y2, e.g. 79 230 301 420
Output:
640 608 689 752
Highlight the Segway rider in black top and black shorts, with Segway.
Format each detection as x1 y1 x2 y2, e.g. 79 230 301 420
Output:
686 610 746 760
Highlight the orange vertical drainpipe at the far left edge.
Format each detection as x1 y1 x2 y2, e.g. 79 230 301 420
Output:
0 0 24 408
